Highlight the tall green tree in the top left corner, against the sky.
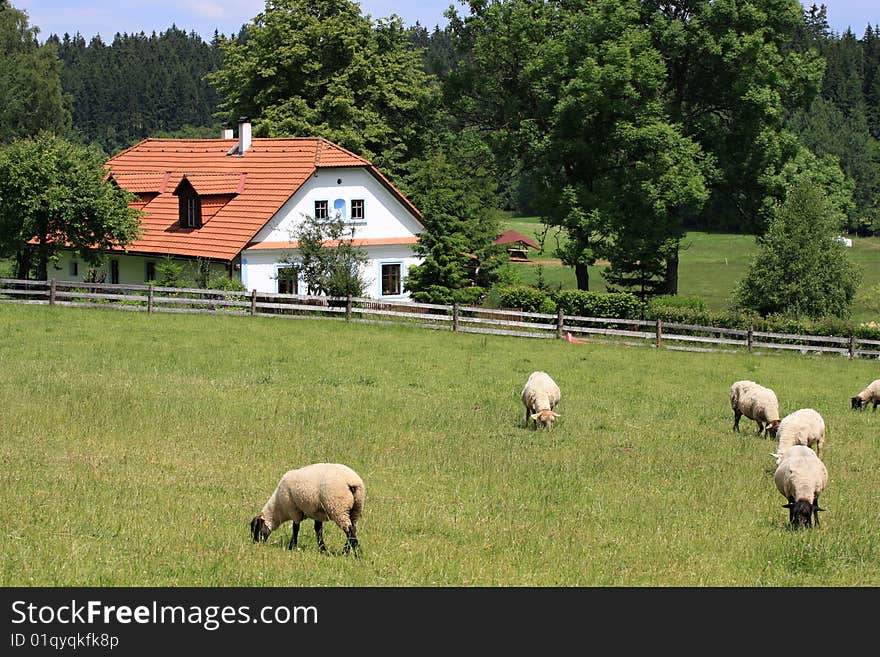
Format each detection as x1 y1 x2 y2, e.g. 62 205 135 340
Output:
0 0 70 144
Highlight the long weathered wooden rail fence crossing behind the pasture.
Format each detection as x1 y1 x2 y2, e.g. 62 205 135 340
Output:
0 278 880 359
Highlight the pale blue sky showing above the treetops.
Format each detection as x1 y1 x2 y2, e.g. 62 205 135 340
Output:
11 0 880 43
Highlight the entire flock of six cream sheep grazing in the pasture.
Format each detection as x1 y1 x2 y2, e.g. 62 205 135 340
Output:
251 371 880 556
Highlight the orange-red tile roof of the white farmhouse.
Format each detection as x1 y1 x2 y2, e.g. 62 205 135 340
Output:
105 138 421 261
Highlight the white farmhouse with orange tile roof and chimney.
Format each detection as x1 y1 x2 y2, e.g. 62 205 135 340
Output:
49 117 424 299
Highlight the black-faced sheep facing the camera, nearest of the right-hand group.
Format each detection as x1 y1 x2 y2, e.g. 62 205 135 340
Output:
773 445 828 527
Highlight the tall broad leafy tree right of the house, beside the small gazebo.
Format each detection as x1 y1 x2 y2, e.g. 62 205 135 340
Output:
447 0 708 289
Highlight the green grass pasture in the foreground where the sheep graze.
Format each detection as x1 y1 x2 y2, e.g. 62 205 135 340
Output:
0 304 880 587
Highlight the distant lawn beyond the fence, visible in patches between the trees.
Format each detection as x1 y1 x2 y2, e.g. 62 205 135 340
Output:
502 217 880 322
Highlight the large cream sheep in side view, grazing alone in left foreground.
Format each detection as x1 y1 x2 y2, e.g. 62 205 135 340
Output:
251 463 365 556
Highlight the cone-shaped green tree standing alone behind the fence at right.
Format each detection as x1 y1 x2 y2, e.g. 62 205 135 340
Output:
733 176 861 319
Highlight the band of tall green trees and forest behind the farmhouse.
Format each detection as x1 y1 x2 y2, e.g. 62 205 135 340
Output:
0 0 880 320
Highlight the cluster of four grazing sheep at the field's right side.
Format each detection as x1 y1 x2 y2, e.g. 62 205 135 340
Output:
730 379 880 527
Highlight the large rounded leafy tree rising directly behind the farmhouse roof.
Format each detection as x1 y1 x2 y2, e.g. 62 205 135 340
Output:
208 0 438 177
